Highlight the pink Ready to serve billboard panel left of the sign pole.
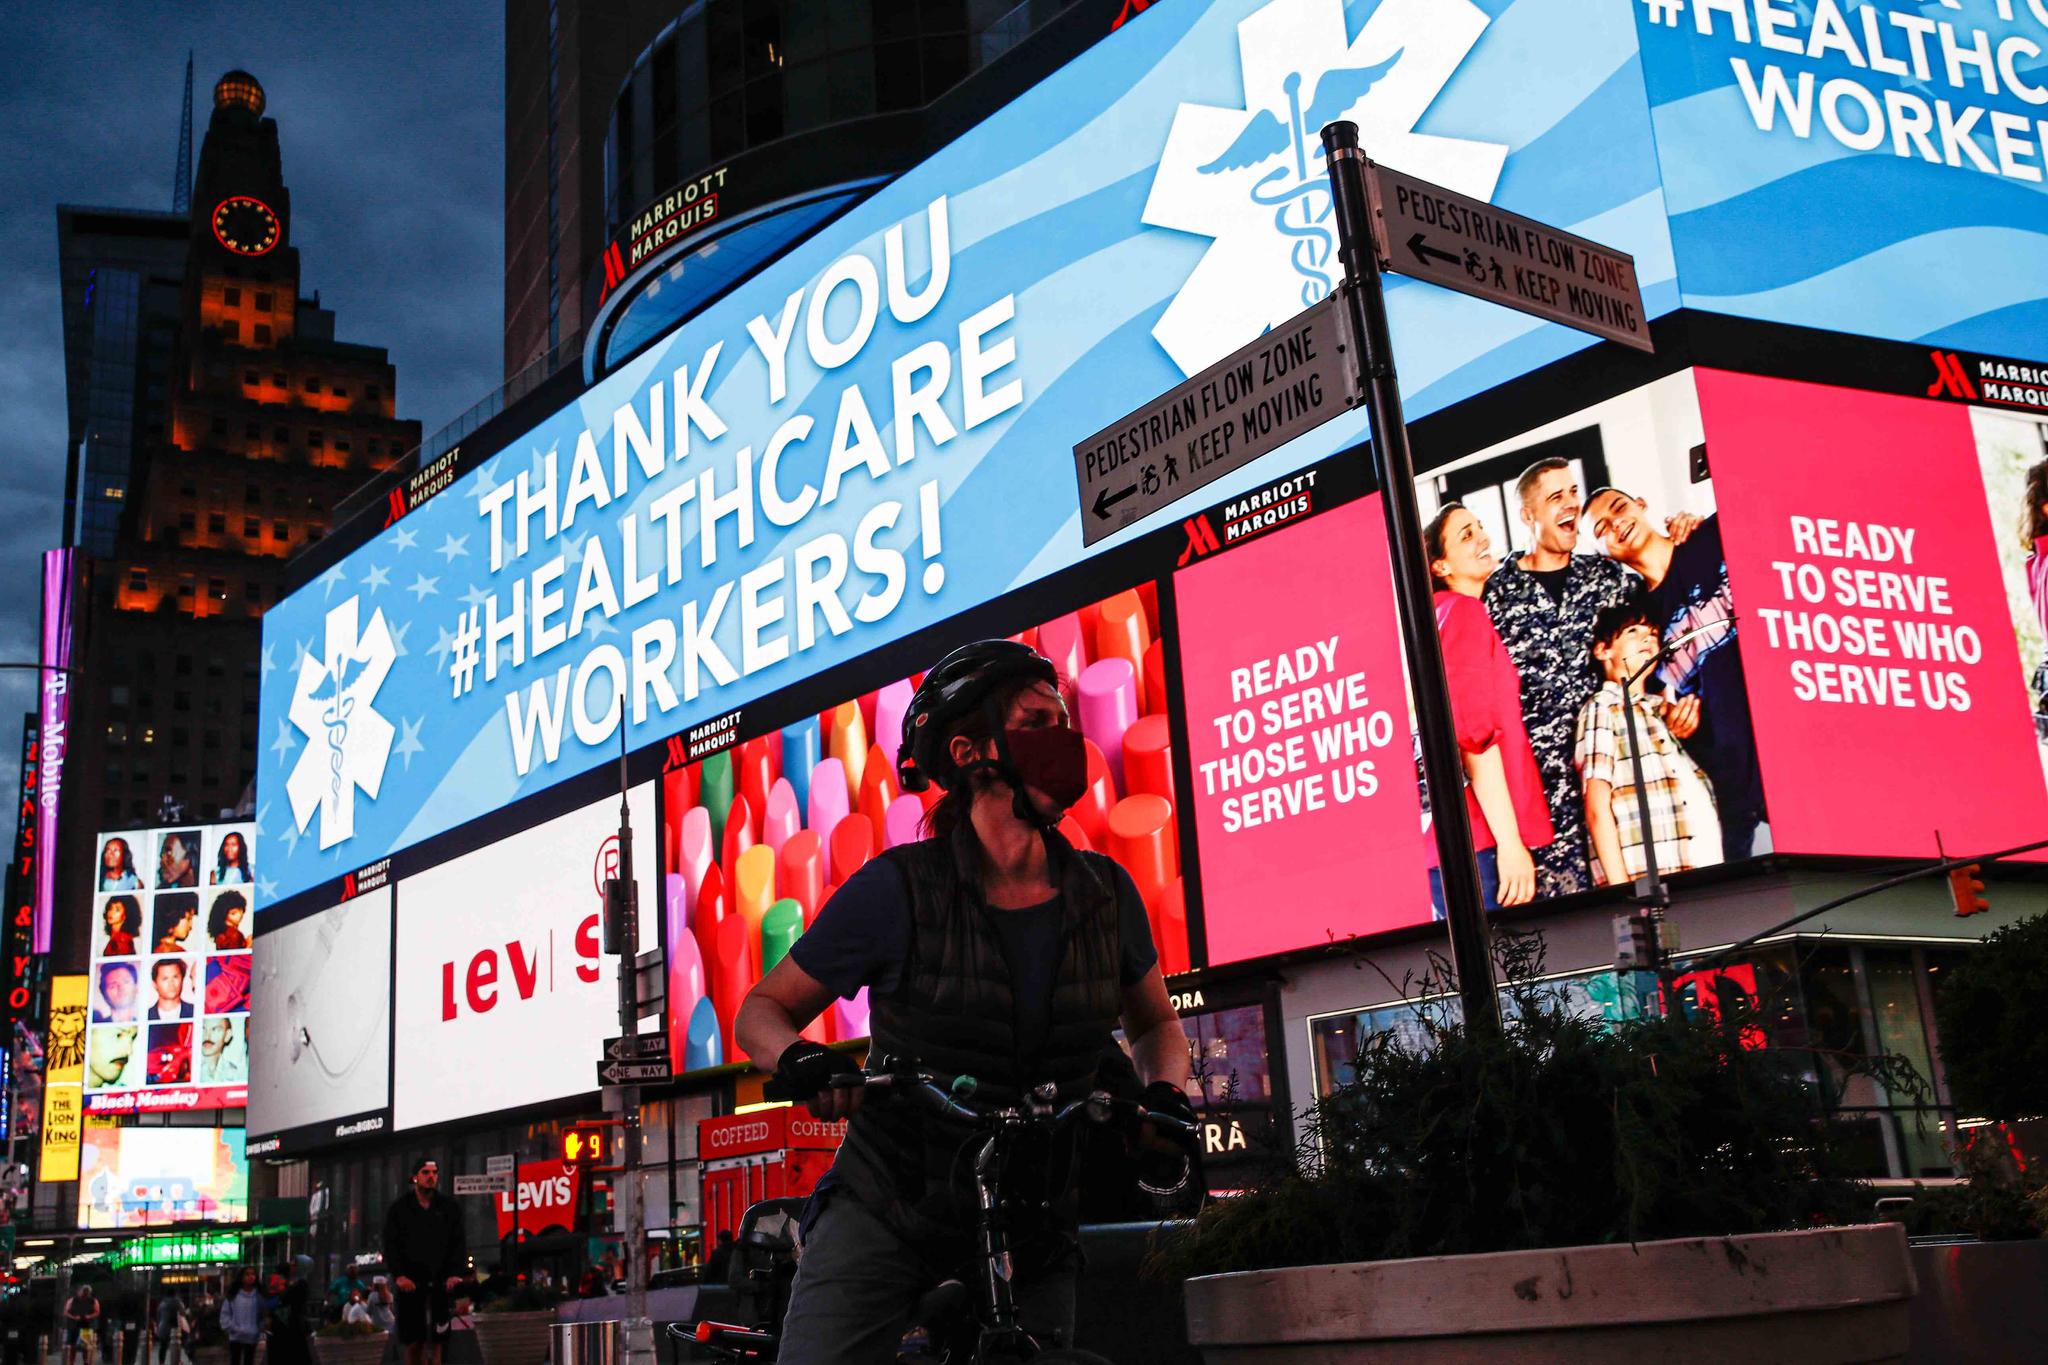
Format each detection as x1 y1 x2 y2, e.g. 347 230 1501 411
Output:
1176 497 1430 962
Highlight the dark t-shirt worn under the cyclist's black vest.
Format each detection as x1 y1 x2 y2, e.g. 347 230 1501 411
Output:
791 857 1159 1052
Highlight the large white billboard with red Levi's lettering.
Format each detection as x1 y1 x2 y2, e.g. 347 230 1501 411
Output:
393 786 659 1128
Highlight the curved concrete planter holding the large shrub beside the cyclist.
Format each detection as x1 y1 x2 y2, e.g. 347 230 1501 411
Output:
1188 1224 1913 1365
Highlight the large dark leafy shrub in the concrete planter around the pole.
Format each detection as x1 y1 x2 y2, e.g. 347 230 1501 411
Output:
1153 935 1923 1279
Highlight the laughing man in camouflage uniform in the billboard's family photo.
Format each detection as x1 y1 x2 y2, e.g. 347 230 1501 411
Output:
1483 456 1696 898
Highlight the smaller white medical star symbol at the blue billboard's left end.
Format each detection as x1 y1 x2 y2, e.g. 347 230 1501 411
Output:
285 598 397 849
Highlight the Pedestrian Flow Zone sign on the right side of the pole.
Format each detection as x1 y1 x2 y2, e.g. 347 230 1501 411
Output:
1366 164 1653 350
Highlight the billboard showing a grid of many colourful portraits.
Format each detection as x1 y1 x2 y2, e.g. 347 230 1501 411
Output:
86 823 264 1113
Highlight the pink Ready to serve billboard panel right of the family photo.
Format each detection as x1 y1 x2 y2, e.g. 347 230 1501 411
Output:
1698 370 2048 855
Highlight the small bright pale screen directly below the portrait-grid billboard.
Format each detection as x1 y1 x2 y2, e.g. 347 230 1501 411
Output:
78 1128 250 1228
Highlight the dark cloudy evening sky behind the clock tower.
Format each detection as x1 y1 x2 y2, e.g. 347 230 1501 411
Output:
0 0 504 818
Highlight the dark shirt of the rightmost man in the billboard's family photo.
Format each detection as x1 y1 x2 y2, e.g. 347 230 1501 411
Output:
1647 516 1763 821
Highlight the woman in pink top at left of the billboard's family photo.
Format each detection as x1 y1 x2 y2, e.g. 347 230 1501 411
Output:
1423 503 1554 905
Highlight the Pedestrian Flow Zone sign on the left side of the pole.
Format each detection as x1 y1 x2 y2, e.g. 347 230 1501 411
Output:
1073 295 1360 544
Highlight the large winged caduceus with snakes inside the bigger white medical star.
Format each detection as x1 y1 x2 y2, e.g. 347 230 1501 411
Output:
1196 49 1405 307
